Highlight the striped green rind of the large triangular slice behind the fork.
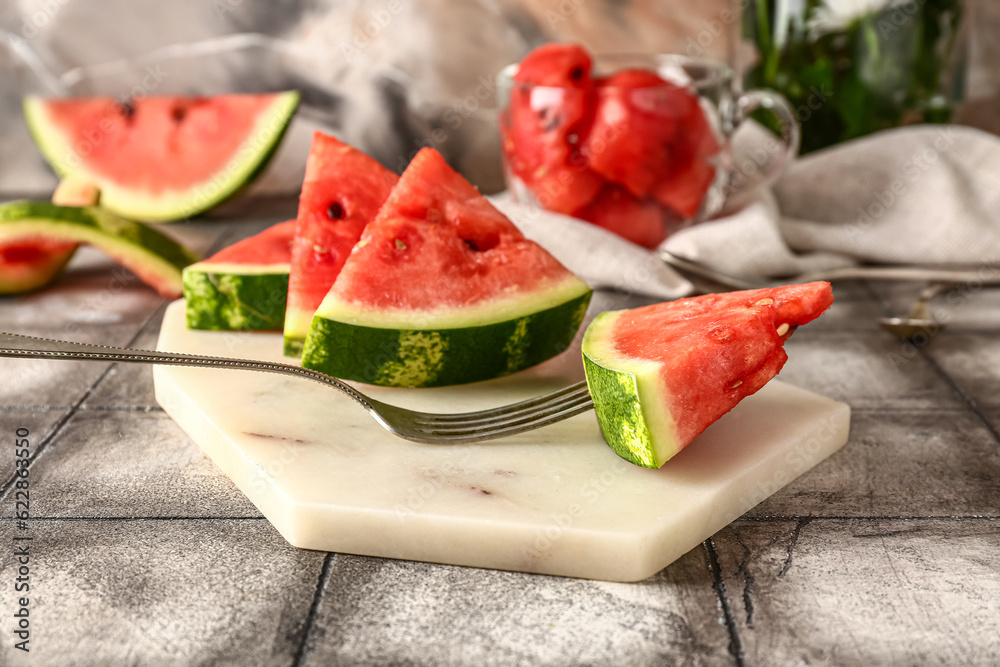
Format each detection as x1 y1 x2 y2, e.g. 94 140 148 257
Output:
302 283 592 387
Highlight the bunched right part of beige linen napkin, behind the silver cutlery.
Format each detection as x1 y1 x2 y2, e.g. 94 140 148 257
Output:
663 125 1000 276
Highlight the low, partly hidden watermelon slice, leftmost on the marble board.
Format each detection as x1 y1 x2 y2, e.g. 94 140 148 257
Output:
184 220 295 331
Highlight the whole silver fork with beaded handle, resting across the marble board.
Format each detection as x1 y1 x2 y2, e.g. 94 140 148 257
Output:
0 332 594 445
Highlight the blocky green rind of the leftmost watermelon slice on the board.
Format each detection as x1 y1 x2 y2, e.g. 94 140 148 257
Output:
184 262 289 331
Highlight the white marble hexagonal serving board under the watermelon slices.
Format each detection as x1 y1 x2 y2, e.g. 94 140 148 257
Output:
154 302 850 581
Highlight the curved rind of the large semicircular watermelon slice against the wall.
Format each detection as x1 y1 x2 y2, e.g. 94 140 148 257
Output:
22 91 299 222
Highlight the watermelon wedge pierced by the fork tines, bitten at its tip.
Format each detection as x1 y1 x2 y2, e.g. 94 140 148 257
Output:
583 282 833 468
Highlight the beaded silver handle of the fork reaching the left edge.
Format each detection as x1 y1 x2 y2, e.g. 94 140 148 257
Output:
0 332 374 410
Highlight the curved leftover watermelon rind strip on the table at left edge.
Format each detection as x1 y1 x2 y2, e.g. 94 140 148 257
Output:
0 200 200 296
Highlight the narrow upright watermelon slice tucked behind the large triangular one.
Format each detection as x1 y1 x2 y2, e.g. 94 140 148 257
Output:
285 132 399 357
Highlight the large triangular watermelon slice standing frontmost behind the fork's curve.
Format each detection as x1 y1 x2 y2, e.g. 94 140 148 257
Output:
302 148 591 387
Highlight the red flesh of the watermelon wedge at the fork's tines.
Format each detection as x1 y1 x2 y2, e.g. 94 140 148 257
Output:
611 282 833 447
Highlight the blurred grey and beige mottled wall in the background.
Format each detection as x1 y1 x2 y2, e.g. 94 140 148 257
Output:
0 0 1000 198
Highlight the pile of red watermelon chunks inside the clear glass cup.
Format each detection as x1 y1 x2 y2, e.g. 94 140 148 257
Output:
500 44 720 246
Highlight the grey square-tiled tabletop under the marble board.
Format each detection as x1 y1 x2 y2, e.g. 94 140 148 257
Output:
0 207 1000 665
